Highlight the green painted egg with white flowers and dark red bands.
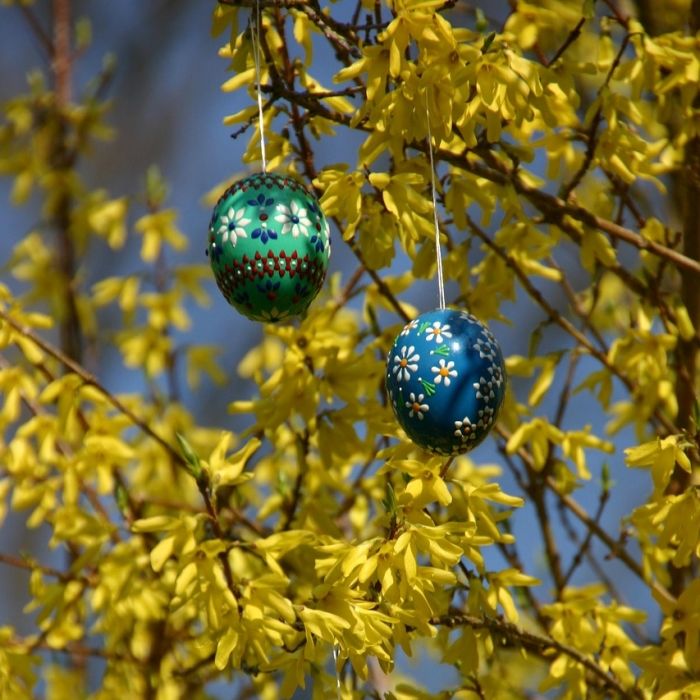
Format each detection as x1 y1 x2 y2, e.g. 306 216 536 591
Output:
207 173 330 321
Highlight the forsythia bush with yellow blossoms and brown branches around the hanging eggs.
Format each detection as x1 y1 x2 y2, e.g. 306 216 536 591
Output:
0 0 700 700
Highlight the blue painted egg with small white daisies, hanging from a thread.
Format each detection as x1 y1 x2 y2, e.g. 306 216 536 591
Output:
386 309 506 455
